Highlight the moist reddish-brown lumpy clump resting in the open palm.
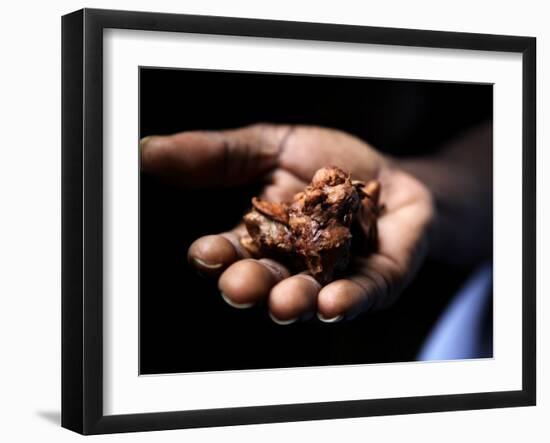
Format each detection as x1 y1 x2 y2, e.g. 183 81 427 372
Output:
241 167 380 284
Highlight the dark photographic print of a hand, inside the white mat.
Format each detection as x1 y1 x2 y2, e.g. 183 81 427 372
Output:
139 67 493 375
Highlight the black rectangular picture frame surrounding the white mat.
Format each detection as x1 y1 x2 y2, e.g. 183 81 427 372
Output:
62 9 536 434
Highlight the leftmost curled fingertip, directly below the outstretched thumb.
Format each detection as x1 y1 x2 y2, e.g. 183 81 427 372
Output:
187 223 251 277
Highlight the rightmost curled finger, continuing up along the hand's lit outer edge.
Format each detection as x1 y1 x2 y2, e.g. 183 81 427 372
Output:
318 172 433 321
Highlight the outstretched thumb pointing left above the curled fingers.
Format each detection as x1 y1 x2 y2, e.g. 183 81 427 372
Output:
140 124 292 188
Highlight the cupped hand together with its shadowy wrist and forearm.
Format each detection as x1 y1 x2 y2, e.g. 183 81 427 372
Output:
140 124 492 324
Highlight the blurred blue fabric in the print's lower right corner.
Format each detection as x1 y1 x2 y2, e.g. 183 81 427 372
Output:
418 264 493 360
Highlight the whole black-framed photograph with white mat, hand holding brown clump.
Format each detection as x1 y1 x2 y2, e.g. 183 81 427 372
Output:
62 9 536 434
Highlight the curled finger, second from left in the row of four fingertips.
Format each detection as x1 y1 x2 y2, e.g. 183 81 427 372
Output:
218 258 290 308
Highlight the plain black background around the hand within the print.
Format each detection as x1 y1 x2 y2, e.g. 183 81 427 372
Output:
139 68 493 374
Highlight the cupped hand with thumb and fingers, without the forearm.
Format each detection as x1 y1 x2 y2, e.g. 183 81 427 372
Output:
140 124 434 324
